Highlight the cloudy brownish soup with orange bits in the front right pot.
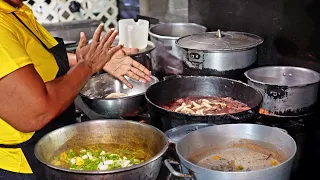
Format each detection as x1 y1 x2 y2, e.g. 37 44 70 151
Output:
190 140 284 172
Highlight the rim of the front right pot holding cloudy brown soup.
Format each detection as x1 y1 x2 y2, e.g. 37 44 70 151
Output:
175 123 297 175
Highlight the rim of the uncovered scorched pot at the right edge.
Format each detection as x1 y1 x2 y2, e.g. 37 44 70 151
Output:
244 66 320 87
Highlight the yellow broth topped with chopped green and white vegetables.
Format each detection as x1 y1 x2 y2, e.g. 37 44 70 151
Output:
51 144 151 171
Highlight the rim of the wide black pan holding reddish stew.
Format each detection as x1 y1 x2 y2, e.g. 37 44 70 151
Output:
145 76 263 117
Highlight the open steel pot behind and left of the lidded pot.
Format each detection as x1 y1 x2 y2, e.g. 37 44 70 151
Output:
149 23 207 79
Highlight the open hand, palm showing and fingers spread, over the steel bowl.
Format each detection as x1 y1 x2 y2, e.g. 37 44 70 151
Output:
103 48 151 88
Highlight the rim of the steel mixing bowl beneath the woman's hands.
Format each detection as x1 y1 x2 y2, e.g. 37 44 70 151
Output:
79 73 159 101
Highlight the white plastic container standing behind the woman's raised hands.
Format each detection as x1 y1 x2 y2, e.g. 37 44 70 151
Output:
118 19 149 49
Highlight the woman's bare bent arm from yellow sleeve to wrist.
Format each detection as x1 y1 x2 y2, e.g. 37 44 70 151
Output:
0 62 93 132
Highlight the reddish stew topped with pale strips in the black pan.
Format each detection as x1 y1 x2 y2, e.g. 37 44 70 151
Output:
162 96 250 115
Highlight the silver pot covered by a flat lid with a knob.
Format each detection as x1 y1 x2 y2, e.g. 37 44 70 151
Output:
176 30 263 80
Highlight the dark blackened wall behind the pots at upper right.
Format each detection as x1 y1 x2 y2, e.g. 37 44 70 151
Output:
188 0 320 71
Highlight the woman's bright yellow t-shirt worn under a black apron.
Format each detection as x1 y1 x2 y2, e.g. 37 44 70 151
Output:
0 0 58 173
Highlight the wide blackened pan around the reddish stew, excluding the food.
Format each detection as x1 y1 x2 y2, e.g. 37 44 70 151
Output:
145 76 262 131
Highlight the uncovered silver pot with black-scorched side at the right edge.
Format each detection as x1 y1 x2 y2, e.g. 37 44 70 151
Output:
245 66 320 117
